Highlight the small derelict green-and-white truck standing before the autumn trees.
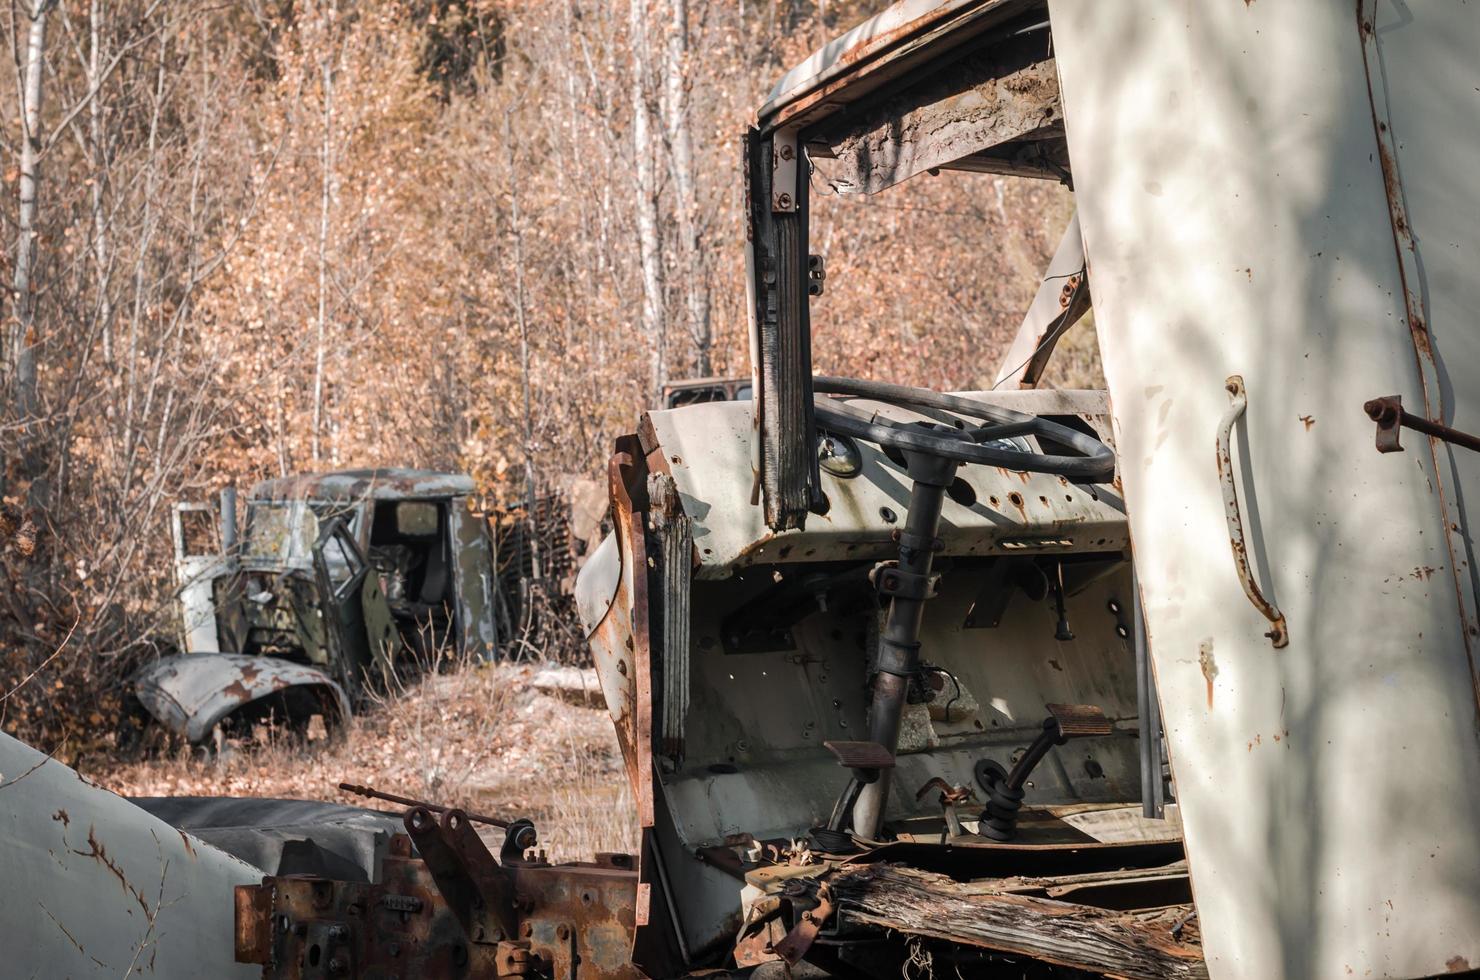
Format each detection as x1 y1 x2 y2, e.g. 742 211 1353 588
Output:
135 469 506 743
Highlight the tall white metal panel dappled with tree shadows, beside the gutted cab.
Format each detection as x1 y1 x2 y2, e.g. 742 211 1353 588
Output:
1049 0 1480 980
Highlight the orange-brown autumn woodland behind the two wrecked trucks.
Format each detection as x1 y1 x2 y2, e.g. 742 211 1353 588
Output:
0 0 1069 756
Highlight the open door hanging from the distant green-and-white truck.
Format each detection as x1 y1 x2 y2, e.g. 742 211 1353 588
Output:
314 517 395 699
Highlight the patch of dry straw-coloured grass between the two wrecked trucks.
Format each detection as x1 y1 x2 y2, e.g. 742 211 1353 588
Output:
89 663 636 860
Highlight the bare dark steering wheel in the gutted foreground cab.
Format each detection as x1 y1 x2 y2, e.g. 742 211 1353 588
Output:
813 377 1114 483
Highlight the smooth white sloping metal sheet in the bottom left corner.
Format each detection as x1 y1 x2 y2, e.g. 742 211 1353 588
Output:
0 736 262 980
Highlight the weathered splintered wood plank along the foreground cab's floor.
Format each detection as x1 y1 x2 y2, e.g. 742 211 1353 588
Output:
829 865 1208 980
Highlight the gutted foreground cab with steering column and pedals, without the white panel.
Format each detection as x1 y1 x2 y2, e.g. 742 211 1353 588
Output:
577 3 1203 976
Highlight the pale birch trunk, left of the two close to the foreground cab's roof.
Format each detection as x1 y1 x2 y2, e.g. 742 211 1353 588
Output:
629 0 667 406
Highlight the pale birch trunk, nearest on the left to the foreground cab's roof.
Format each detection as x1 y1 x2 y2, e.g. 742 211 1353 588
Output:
663 0 713 377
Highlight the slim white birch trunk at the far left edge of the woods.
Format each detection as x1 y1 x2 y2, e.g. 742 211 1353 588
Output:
9 0 55 419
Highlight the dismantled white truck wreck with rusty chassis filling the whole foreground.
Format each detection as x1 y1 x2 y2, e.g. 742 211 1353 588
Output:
0 0 1480 980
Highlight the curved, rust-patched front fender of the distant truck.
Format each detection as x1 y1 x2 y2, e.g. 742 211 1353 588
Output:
133 653 352 743
